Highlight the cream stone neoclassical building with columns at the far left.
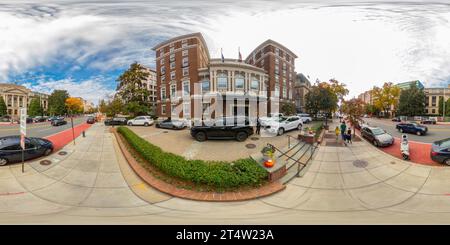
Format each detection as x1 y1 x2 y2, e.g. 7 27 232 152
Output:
0 83 48 120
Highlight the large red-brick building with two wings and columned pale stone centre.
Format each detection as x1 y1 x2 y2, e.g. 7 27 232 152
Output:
153 33 297 119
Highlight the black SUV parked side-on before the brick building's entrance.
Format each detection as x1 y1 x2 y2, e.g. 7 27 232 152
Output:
191 124 253 142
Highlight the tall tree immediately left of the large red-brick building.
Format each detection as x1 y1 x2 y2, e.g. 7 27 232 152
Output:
116 62 151 116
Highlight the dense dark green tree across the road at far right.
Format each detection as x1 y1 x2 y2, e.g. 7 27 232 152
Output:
397 85 426 117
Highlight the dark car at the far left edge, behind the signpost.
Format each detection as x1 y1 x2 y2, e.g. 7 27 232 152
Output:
0 136 53 166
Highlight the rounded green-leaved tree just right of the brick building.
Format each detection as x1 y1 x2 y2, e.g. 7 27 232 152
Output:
305 85 338 125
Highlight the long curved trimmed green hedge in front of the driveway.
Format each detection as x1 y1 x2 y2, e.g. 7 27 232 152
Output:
118 127 267 189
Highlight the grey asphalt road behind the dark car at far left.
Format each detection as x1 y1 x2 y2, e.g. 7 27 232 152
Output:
0 117 86 138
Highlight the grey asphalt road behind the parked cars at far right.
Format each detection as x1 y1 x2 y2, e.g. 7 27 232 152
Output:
363 118 450 143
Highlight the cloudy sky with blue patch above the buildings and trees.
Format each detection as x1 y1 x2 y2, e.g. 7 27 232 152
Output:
0 0 450 103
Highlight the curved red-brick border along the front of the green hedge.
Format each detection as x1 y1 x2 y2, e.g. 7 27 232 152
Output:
111 129 286 202
